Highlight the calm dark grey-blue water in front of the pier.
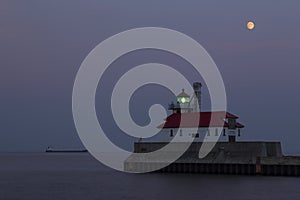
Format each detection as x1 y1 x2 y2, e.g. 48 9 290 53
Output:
0 153 300 200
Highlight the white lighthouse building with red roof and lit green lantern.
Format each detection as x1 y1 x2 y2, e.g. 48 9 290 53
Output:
143 83 244 142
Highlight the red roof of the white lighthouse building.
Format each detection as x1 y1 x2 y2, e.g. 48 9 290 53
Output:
158 111 244 128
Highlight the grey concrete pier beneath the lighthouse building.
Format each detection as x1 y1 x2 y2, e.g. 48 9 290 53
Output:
124 142 300 176
